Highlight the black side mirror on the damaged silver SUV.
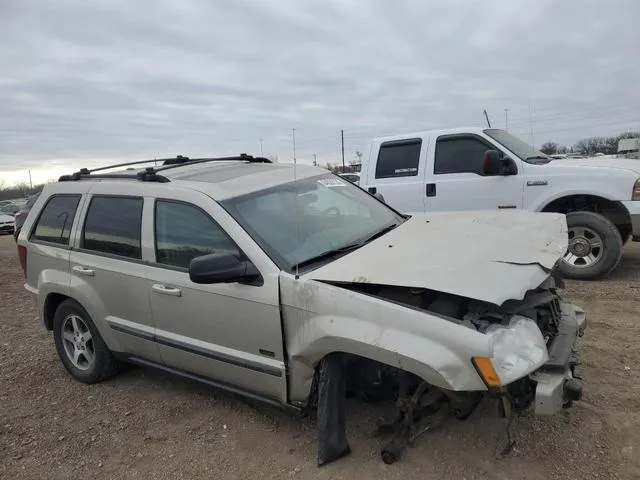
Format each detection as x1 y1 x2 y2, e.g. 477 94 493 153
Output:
189 253 260 284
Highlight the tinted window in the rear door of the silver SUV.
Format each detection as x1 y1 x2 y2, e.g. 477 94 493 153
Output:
82 196 143 259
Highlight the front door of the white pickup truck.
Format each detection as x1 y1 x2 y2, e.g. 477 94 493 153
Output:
424 134 523 212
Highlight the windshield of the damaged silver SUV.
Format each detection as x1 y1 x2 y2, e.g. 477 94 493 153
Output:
221 173 404 272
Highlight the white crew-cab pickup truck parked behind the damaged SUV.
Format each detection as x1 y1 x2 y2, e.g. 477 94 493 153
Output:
360 128 640 280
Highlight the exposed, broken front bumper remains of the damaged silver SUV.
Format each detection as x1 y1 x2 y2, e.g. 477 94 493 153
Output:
530 303 586 415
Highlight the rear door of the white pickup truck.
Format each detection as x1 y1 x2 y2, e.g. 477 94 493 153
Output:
367 138 428 213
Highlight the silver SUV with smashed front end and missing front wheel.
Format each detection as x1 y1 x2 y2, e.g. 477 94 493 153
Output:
18 154 585 464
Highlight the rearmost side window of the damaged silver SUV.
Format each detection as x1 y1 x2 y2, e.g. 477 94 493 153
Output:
30 195 80 245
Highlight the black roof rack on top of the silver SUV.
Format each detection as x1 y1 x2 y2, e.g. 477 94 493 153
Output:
58 153 271 183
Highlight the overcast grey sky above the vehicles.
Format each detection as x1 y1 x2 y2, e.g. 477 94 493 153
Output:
0 0 640 186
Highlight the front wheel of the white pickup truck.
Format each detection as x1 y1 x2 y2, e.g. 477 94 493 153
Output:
559 212 623 280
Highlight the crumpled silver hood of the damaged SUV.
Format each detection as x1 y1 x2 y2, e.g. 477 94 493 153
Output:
302 211 568 305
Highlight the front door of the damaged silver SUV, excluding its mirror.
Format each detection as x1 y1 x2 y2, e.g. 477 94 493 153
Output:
149 190 287 403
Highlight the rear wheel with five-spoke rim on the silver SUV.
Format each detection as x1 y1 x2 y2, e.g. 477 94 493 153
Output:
53 299 120 384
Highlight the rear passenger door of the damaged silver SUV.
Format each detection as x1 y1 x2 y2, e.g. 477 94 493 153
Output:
69 182 161 363
